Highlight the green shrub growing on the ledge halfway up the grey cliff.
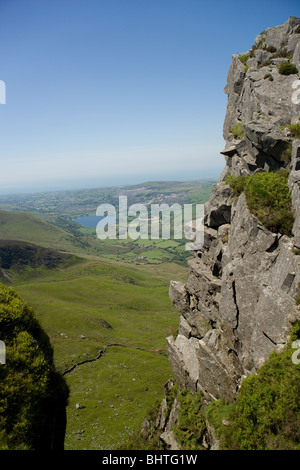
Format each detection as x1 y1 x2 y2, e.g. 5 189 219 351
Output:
226 170 294 235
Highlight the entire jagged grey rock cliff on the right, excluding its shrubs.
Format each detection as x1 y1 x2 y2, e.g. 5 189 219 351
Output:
166 17 300 402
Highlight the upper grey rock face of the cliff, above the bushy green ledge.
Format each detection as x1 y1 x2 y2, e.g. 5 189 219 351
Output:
221 17 300 181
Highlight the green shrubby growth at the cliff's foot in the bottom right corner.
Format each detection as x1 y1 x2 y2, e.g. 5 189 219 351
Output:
205 323 300 450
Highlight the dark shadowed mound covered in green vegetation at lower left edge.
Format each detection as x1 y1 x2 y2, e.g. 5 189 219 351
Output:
0 284 68 450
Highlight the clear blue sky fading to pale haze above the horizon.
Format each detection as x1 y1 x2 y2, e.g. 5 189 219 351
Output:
0 0 300 194
